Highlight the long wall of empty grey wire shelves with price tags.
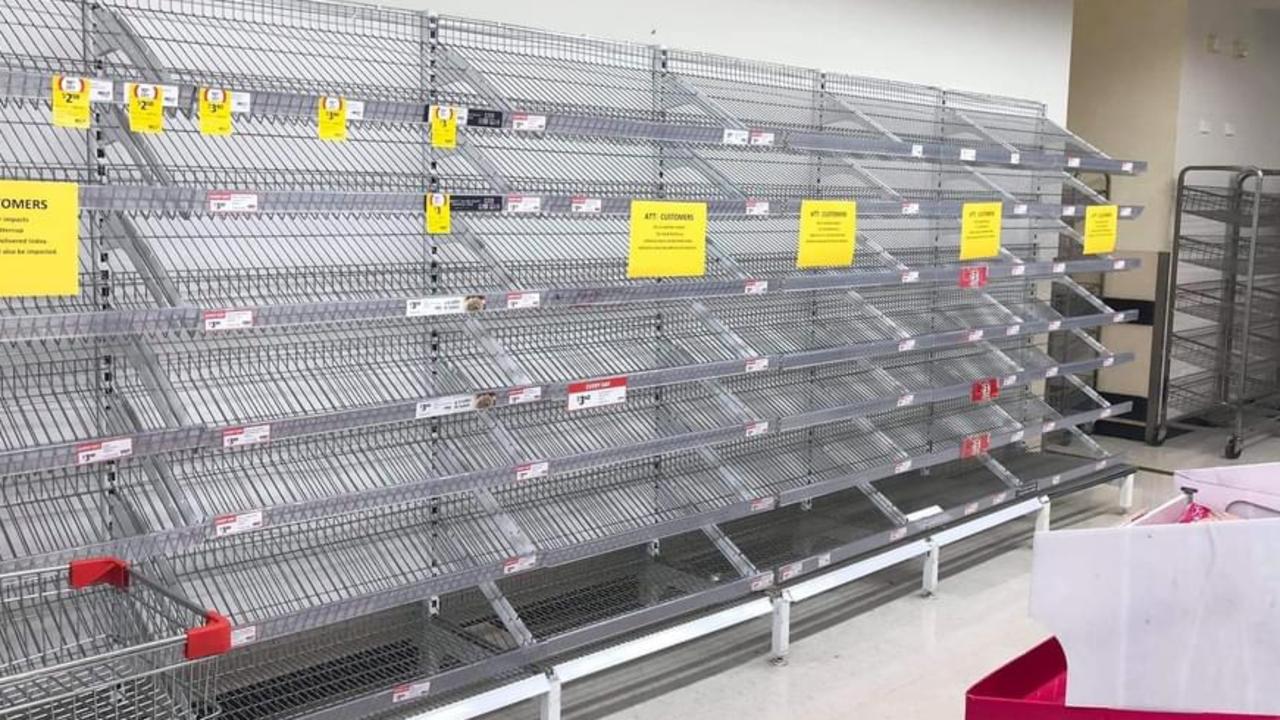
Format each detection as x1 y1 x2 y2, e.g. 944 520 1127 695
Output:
0 0 1144 720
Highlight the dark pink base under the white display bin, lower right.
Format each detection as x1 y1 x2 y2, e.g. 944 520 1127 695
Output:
965 638 1280 720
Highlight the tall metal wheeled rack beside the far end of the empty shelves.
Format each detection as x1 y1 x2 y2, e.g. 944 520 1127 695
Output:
1147 167 1280 459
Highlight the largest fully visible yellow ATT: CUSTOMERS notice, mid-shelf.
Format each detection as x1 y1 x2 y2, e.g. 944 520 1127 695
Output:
627 200 707 278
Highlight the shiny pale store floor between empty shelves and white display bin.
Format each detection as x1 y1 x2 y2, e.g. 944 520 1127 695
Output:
481 433 1280 720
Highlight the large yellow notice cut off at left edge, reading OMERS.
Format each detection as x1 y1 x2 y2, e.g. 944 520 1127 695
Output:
0 181 79 297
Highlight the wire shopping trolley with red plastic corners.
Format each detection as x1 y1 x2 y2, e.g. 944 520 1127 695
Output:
0 557 230 720
